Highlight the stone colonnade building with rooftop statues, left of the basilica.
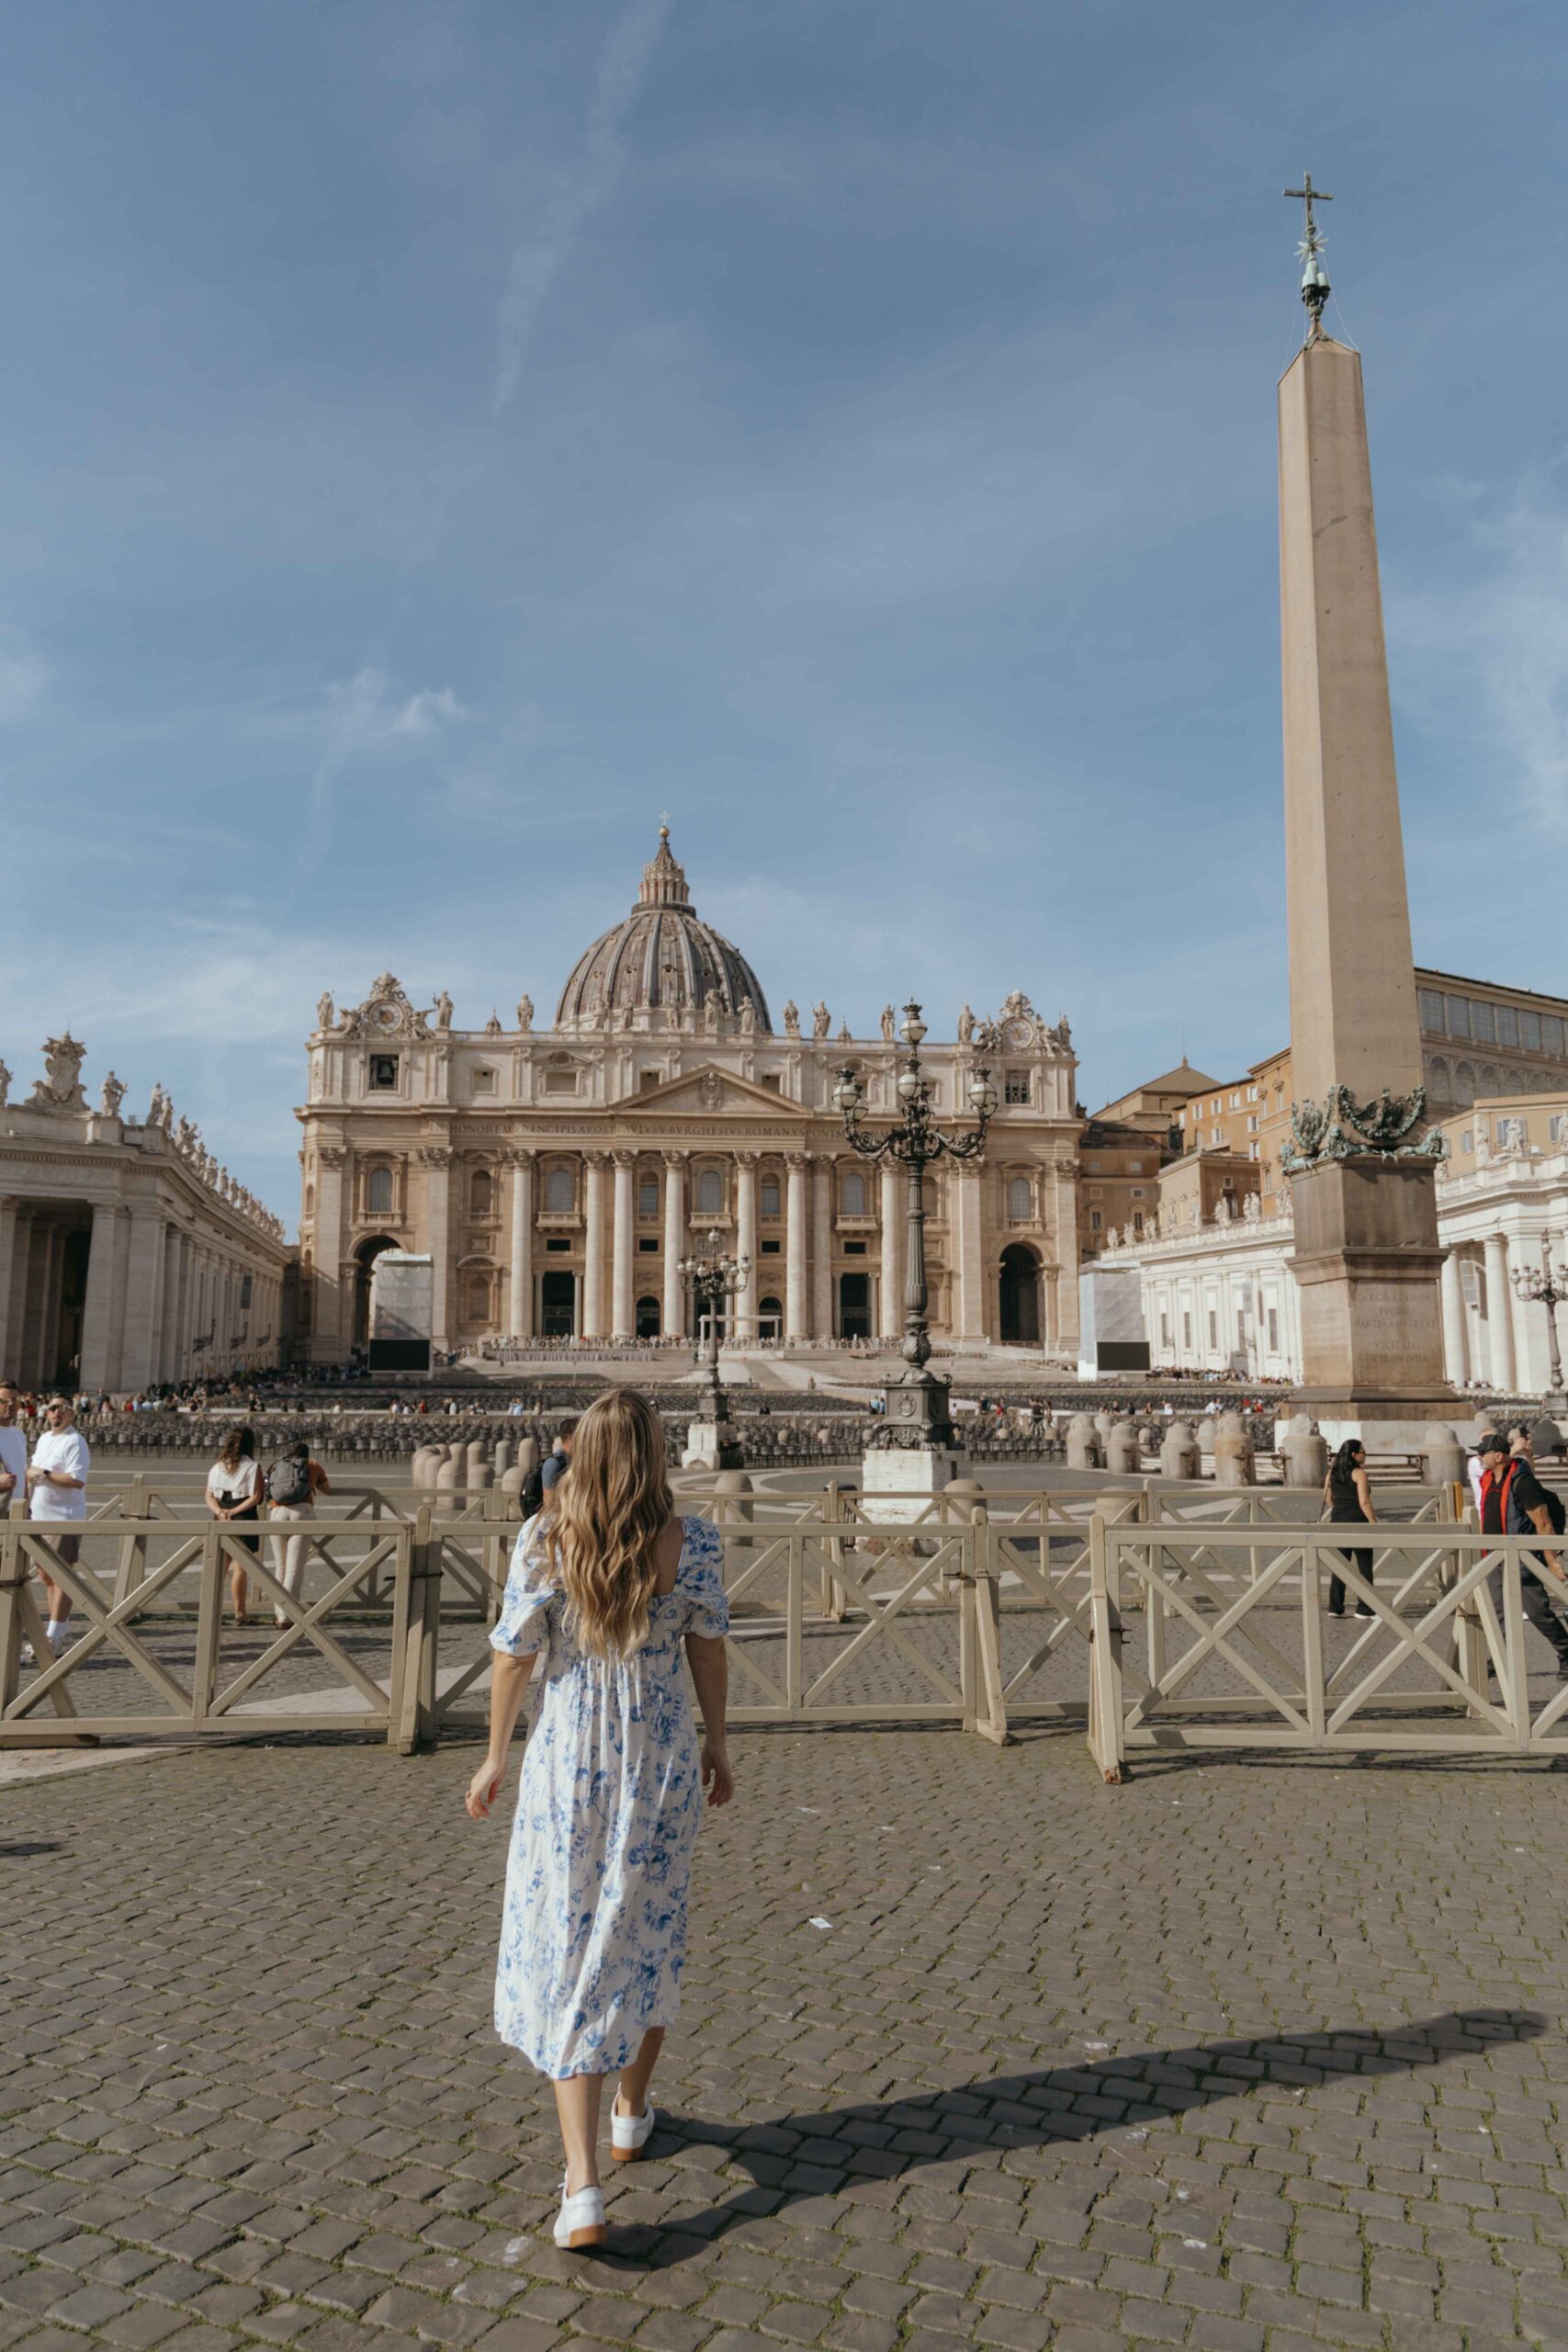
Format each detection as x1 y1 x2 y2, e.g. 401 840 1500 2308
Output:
0 1035 291 1393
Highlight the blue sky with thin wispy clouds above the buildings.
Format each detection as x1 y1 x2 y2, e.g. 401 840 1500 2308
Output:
0 0 1568 1226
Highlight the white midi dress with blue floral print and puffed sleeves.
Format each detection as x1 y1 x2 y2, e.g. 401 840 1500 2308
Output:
489 1520 728 2079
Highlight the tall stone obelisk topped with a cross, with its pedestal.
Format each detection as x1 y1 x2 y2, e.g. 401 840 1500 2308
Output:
1279 179 1453 1444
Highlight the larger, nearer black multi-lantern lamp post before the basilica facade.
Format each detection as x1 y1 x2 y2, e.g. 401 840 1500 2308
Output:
832 1002 997 1452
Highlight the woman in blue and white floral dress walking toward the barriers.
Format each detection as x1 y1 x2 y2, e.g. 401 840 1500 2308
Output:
468 1387 733 2246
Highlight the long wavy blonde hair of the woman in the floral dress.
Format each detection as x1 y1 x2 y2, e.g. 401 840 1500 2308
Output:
541 1387 674 1658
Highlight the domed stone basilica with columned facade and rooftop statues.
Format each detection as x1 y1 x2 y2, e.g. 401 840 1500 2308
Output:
299 828 1081 1362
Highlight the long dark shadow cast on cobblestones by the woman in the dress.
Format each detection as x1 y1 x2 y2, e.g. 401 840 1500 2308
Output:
600 2008 1547 2269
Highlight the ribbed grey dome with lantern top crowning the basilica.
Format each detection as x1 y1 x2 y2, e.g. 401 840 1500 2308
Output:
555 826 773 1035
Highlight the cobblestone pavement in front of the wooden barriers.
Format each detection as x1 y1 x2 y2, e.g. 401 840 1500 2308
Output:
0 1731 1568 2352
